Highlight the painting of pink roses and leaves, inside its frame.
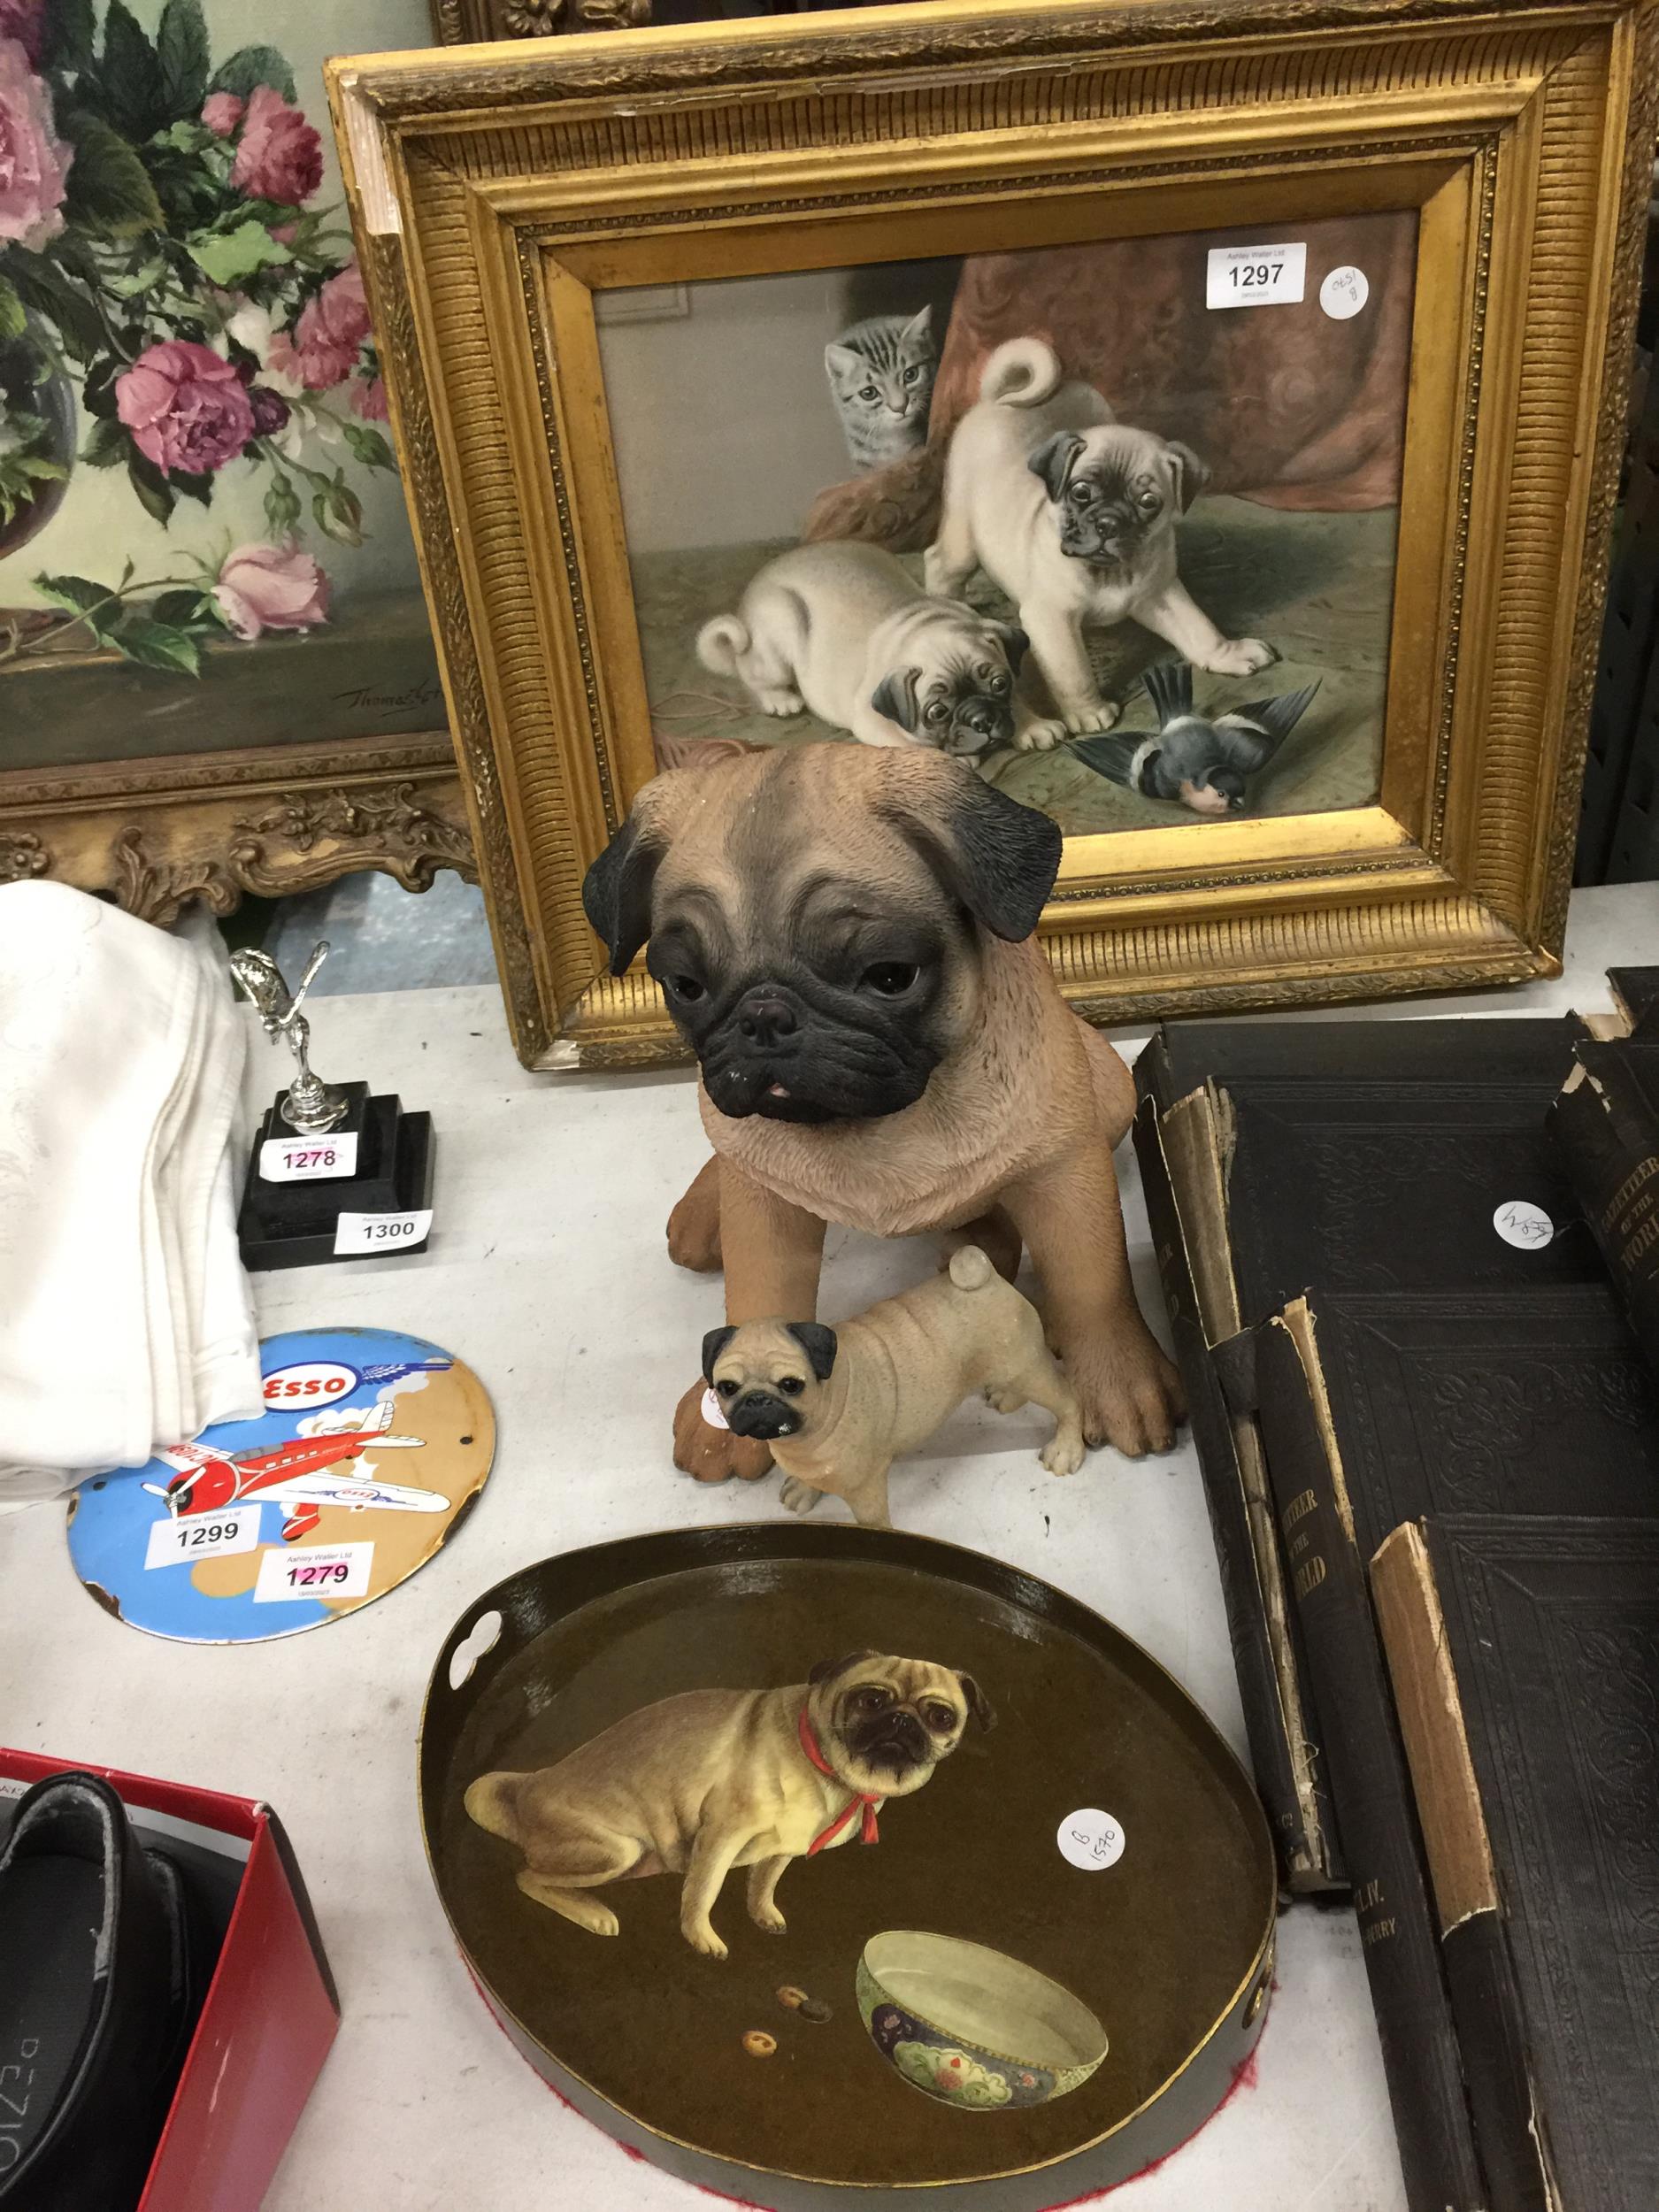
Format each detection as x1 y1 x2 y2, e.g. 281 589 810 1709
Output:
0 0 442 765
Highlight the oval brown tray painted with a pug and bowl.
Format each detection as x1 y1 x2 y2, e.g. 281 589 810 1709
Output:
420 1526 1277 2212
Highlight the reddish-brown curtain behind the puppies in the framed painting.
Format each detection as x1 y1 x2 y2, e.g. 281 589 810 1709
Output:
805 212 1418 553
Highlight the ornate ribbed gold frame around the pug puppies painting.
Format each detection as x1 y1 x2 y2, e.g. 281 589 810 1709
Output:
330 0 1659 1066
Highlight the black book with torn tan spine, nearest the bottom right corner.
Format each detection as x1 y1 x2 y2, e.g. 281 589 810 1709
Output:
1371 1517 1659 2212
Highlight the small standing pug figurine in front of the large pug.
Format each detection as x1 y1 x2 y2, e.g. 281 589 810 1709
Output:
703 1246 1084 1529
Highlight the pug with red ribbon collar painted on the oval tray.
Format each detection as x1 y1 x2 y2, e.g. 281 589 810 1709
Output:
467 1653 995 1958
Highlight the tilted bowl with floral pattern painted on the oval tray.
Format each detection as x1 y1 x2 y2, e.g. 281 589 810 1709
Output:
858 1929 1106 2113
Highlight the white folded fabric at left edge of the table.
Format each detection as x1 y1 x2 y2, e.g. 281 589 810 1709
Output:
0 883 261 1498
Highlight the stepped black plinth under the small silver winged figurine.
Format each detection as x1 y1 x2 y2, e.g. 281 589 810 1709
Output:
237 1084 434 1270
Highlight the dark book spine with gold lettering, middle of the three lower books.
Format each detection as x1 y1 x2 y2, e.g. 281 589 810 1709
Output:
1256 1301 1489 2212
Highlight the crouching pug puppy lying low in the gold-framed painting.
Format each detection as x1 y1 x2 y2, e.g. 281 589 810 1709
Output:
697 544 1066 759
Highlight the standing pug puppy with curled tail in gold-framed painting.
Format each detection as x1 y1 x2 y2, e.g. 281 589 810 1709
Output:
925 339 1274 734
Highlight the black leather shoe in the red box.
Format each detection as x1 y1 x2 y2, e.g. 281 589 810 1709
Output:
0 1774 208 2212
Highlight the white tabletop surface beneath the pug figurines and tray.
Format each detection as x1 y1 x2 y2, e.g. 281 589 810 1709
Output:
0 885 1659 2212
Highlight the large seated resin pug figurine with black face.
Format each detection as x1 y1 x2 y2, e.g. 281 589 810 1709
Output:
584 743 1181 1482
